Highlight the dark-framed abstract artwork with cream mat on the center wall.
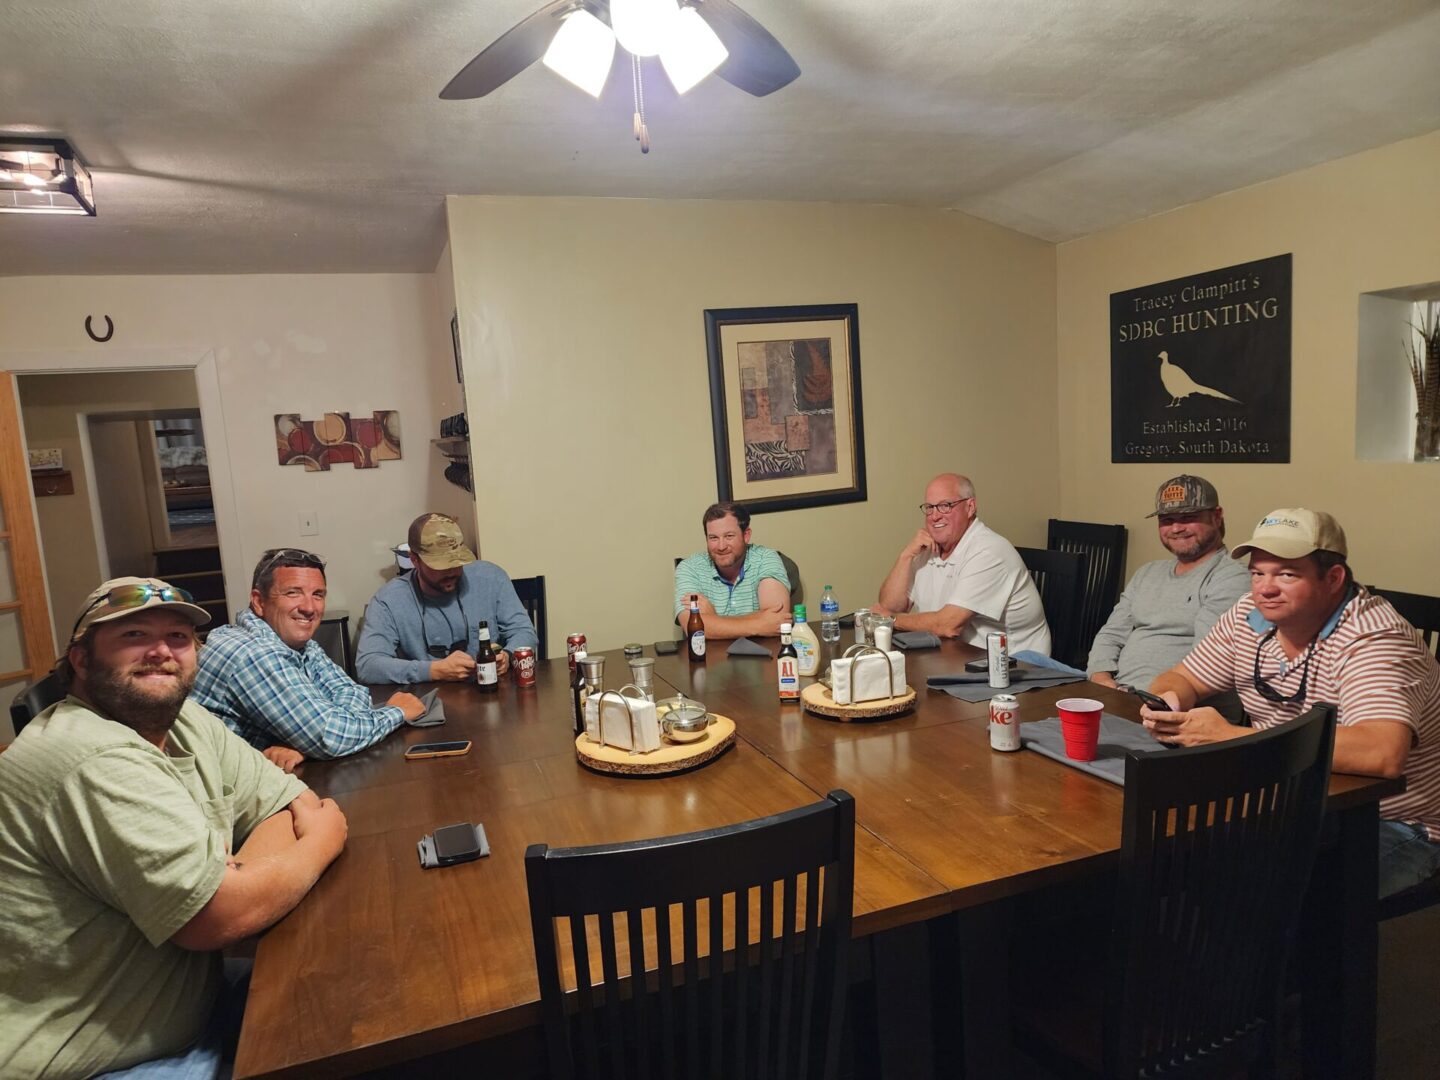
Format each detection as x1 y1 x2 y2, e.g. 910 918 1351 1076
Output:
706 304 867 514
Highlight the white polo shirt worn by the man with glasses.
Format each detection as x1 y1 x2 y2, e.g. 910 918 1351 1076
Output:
910 518 1050 657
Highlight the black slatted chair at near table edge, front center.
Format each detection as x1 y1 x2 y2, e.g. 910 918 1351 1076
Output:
526 791 855 1080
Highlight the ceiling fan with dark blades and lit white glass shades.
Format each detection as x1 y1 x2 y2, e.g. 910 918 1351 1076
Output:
441 0 801 153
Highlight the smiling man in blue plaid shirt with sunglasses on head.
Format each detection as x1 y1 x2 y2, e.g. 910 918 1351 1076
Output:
192 547 425 772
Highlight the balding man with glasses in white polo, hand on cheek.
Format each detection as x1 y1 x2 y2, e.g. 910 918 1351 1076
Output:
873 472 1050 657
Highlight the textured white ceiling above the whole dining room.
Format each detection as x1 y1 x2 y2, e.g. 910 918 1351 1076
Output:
0 0 1440 275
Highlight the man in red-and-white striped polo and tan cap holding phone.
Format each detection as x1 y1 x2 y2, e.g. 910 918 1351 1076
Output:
1140 508 1440 897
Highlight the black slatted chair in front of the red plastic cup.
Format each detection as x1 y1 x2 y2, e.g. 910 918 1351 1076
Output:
1015 704 1335 1080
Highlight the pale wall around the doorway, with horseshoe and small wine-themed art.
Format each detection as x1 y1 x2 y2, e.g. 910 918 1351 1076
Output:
0 274 469 650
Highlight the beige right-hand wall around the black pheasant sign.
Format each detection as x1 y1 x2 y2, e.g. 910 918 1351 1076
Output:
1057 132 1440 593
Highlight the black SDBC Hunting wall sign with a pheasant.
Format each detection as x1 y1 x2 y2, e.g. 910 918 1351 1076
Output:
1110 255 1290 462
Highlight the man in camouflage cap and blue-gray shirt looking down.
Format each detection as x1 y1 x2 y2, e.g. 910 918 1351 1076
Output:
356 514 537 684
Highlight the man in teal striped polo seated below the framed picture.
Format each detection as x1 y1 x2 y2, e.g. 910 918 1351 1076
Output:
675 503 791 638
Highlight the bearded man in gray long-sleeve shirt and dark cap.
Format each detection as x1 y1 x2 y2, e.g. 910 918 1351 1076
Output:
1086 475 1250 688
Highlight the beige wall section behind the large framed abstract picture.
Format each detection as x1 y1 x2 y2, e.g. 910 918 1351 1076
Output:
448 197 1058 654
